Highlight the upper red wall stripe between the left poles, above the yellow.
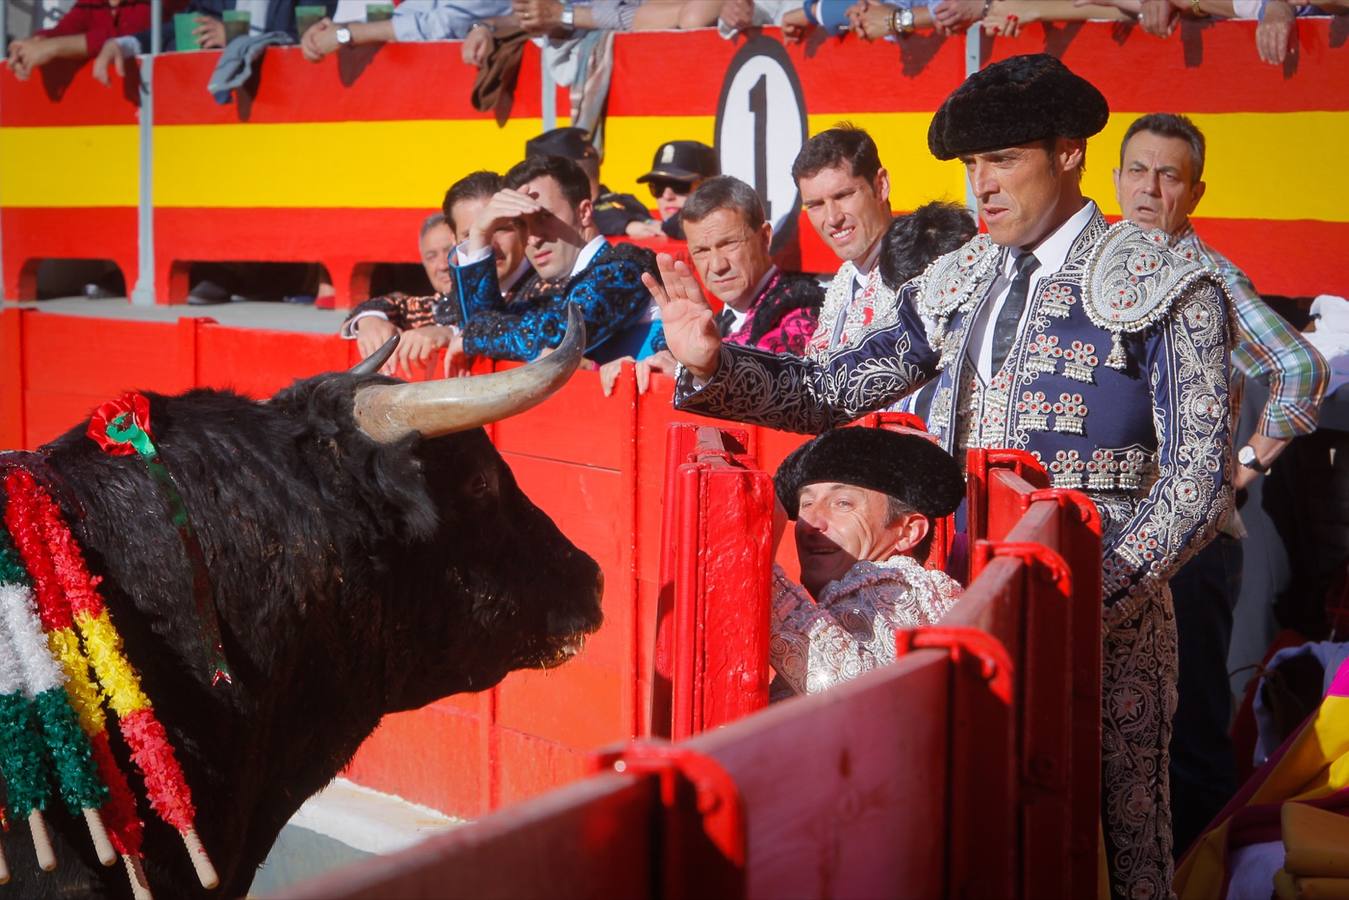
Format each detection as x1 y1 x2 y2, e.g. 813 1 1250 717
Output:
155 42 547 126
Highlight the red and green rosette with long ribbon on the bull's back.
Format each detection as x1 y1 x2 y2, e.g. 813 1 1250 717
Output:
85 393 233 685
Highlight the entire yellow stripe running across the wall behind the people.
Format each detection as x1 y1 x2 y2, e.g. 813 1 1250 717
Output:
0 112 1349 221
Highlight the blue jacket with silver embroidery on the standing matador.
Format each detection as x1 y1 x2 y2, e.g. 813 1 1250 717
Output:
675 212 1232 604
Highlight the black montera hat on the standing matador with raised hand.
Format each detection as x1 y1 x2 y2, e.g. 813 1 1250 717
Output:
928 53 1110 159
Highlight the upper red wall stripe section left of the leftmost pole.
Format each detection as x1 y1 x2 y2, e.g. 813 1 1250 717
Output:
0 61 140 127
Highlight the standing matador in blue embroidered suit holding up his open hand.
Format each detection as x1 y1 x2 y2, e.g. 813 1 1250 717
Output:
653 54 1232 899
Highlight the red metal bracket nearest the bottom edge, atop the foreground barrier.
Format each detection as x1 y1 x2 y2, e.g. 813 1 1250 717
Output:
591 741 747 899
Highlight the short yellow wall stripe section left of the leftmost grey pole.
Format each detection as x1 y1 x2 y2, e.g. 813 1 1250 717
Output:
0 125 140 206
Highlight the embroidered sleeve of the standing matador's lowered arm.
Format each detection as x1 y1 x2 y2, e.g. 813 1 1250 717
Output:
1102 279 1232 606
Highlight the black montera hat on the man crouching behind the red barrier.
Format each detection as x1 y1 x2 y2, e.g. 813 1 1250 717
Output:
773 428 965 518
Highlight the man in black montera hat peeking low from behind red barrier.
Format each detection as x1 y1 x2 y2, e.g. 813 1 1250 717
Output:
769 428 965 699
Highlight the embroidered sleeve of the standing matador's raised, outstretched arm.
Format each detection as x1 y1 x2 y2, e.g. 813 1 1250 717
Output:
675 313 936 434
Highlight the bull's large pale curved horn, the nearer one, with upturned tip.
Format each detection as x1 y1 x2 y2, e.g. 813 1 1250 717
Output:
352 305 585 444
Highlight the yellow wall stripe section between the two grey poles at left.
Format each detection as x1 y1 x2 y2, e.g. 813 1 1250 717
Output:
155 119 541 208
